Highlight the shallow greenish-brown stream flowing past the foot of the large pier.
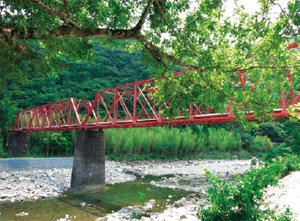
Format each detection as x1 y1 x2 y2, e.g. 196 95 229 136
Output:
0 175 196 220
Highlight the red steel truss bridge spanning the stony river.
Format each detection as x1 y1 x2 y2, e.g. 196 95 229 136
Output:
12 43 300 132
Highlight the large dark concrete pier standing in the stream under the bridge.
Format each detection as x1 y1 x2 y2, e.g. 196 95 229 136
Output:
70 130 105 193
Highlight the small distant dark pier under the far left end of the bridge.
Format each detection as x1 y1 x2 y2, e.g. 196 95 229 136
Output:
7 133 30 155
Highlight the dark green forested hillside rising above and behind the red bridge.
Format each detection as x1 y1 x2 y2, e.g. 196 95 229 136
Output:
13 41 153 109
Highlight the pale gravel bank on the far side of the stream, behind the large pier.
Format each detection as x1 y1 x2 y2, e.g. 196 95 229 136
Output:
0 158 250 202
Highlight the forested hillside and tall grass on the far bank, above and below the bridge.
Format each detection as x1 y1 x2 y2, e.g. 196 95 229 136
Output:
0 42 300 159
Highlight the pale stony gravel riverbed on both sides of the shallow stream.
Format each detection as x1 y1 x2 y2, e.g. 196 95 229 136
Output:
0 158 300 220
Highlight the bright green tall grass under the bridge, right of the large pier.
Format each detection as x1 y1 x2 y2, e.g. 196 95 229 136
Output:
105 126 242 157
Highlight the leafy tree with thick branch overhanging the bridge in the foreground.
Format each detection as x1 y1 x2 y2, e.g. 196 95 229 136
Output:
0 0 300 125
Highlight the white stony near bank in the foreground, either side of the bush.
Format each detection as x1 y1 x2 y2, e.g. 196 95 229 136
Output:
100 171 300 221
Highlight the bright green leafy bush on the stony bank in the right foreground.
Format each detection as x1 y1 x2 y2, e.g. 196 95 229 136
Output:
198 155 300 221
